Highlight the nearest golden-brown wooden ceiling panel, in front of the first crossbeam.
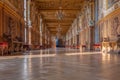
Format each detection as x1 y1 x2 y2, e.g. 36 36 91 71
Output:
35 0 84 10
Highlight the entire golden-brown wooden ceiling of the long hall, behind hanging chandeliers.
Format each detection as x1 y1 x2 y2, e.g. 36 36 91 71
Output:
33 0 85 34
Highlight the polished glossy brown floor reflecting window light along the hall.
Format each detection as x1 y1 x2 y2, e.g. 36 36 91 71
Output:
0 49 120 80
